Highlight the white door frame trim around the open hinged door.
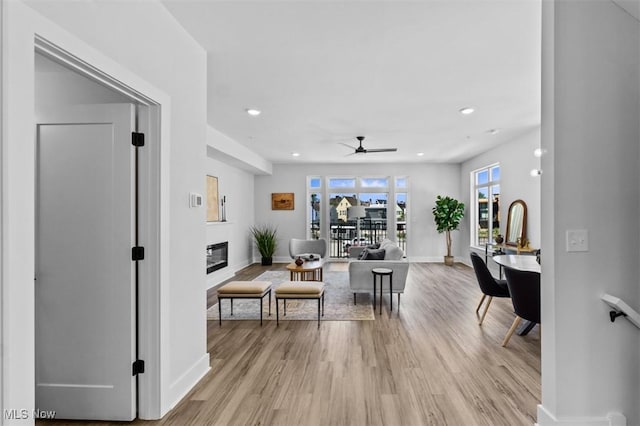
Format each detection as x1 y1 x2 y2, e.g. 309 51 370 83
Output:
34 35 170 419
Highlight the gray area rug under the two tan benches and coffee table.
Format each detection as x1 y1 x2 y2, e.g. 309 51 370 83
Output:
207 270 375 321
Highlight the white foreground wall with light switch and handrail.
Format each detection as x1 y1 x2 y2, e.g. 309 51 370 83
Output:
538 0 640 425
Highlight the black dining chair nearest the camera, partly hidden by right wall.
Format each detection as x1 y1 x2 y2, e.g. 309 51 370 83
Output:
502 268 540 347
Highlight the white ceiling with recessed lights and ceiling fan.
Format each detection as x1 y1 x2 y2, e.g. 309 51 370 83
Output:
164 0 541 163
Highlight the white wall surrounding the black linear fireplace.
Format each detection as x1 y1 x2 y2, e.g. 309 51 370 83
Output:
206 145 254 288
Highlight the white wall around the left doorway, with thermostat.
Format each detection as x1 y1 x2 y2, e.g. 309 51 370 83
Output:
2 0 209 423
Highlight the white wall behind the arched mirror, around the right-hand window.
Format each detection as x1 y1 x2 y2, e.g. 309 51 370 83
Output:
460 128 540 271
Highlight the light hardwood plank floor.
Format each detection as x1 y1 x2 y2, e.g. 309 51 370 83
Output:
39 263 540 426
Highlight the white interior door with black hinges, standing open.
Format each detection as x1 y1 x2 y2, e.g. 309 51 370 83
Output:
35 104 136 420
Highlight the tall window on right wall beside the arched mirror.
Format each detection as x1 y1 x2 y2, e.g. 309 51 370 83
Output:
471 164 500 246
